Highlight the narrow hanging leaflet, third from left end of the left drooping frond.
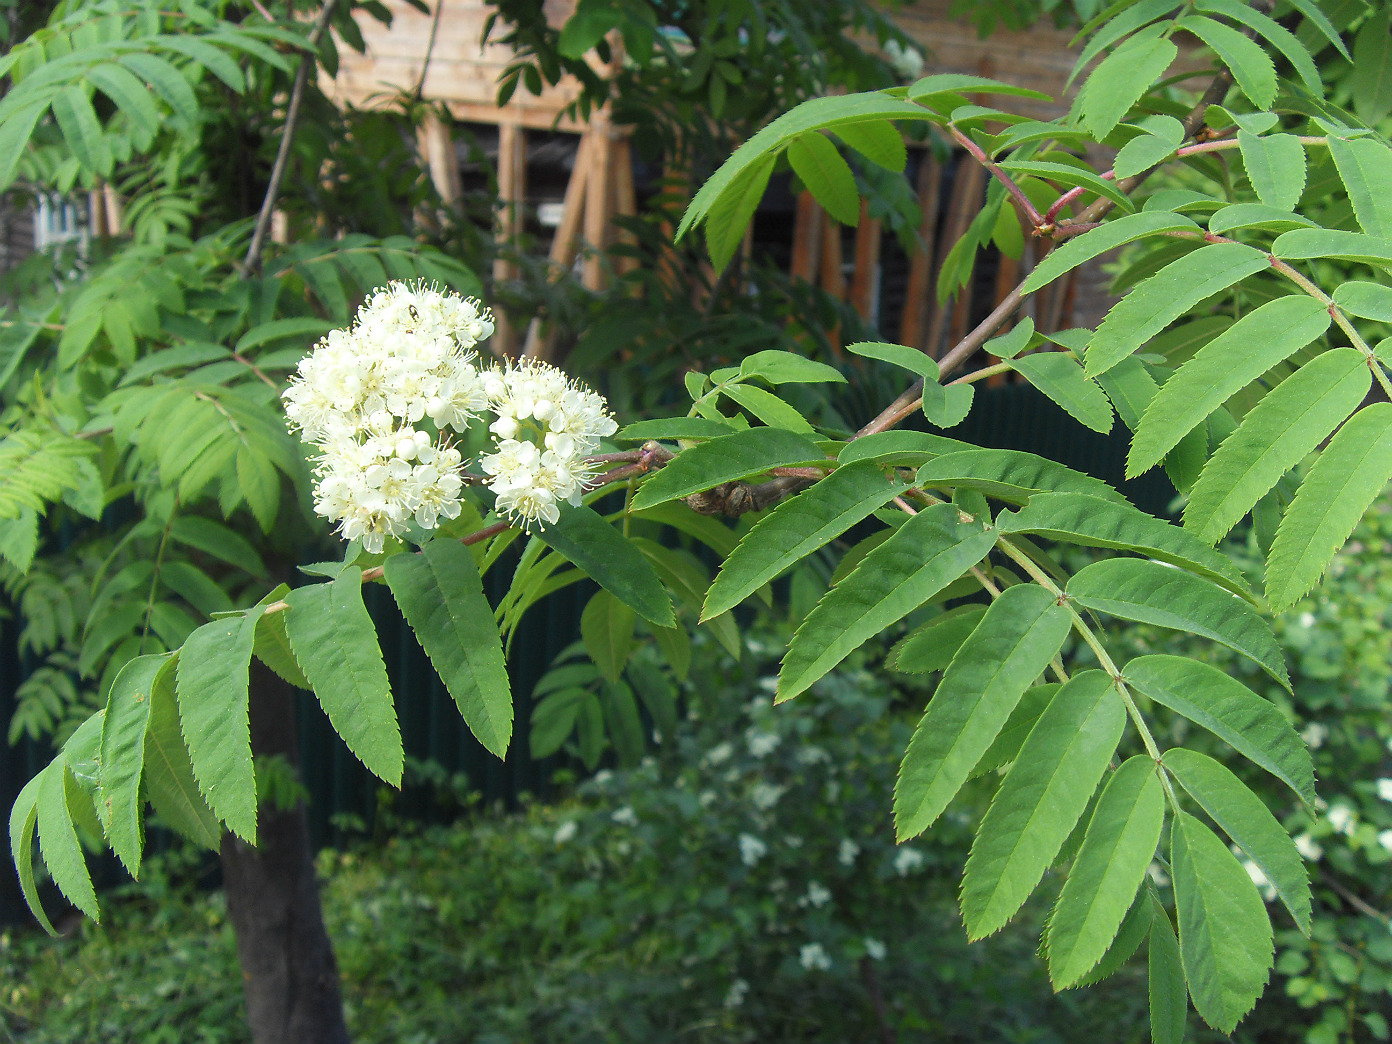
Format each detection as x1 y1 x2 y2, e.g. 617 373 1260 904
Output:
99 653 174 877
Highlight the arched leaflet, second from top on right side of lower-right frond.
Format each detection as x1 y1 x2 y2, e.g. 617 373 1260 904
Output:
995 493 1254 601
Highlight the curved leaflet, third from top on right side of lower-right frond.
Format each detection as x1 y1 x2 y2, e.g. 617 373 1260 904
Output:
1068 558 1290 690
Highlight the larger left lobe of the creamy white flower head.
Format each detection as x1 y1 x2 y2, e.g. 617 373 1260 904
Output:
283 283 493 551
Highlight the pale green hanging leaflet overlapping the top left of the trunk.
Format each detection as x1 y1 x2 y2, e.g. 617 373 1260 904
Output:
175 607 262 845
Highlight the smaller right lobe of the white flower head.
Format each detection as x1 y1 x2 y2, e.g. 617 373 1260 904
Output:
479 359 618 529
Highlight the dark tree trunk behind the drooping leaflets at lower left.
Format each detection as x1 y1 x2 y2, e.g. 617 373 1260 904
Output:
221 660 348 1044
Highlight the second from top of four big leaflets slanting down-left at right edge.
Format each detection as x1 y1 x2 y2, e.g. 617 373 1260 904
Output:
1126 294 1331 477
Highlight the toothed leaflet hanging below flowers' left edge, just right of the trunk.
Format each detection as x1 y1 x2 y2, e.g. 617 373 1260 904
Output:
285 565 403 786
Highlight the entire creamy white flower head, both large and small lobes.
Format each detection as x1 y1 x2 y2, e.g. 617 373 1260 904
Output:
283 283 618 553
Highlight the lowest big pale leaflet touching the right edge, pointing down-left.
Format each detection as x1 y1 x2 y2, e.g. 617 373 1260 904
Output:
1267 402 1392 612
